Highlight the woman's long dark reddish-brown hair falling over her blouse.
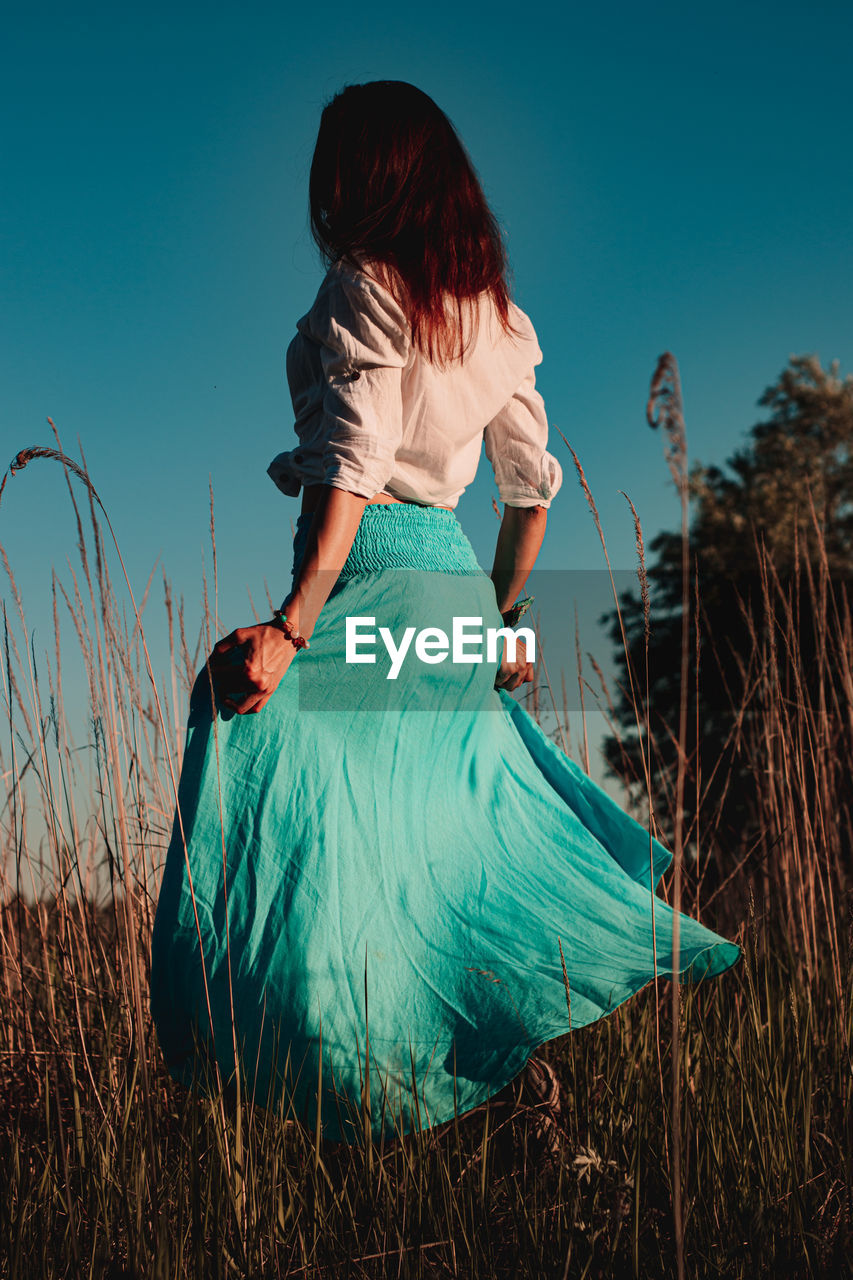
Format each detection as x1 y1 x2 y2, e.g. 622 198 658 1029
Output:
309 81 512 365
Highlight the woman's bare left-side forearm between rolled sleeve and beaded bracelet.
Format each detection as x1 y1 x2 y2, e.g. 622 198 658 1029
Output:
284 485 368 639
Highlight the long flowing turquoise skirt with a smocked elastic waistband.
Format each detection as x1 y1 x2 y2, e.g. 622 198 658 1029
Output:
150 503 740 1140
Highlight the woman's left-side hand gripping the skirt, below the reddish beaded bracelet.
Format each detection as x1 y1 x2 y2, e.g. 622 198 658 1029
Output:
209 622 297 716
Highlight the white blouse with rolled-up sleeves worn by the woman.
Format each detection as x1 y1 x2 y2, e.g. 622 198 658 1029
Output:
268 262 562 508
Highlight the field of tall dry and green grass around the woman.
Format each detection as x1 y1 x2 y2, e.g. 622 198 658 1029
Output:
0 435 853 1280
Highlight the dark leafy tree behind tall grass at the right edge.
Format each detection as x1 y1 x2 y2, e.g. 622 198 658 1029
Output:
602 356 853 911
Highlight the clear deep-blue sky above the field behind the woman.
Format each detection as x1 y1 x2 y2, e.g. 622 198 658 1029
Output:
0 0 853 768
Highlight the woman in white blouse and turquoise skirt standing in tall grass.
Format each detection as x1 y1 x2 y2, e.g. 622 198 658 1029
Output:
151 81 740 1140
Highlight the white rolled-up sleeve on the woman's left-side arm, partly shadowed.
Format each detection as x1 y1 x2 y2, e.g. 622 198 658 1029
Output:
306 271 411 498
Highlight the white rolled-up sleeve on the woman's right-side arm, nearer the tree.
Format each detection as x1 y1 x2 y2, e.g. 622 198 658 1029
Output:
483 369 562 507
